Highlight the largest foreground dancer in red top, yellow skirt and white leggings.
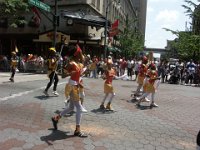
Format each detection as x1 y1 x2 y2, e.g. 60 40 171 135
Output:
52 45 87 137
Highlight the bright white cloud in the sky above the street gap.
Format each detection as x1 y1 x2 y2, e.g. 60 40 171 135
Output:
156 9 180 24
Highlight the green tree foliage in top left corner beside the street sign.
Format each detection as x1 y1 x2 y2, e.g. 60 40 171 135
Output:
0 0 29 27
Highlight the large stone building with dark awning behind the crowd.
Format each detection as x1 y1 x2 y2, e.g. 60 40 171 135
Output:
0 0 147 56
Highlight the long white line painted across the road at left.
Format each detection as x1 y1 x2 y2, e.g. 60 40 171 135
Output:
0 82 66 102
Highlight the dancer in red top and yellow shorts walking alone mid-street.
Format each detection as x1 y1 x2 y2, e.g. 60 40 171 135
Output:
100 59 116 110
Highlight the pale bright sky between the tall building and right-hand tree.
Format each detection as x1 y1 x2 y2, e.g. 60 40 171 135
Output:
145 0 198 48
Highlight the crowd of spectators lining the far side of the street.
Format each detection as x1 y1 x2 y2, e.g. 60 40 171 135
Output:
0 54 200 85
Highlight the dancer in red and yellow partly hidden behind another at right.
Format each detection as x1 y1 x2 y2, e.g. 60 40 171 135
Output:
134 56 148 100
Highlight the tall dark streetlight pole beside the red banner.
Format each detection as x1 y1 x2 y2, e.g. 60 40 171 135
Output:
104 0 120 58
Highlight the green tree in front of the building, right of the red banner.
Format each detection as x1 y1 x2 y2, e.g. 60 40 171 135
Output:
119 19 144 57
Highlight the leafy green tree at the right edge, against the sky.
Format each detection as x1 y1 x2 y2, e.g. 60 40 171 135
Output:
164 0 200 60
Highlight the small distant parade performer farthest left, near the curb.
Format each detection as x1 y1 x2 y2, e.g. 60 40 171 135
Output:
9 51 18 82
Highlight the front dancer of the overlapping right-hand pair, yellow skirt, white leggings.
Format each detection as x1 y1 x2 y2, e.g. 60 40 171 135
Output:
136 63 160 108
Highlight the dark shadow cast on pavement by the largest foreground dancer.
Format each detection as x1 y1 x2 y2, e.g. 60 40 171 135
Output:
40 129 72 145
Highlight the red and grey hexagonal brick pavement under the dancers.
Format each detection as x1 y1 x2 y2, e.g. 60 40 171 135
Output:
0 72 200 150
